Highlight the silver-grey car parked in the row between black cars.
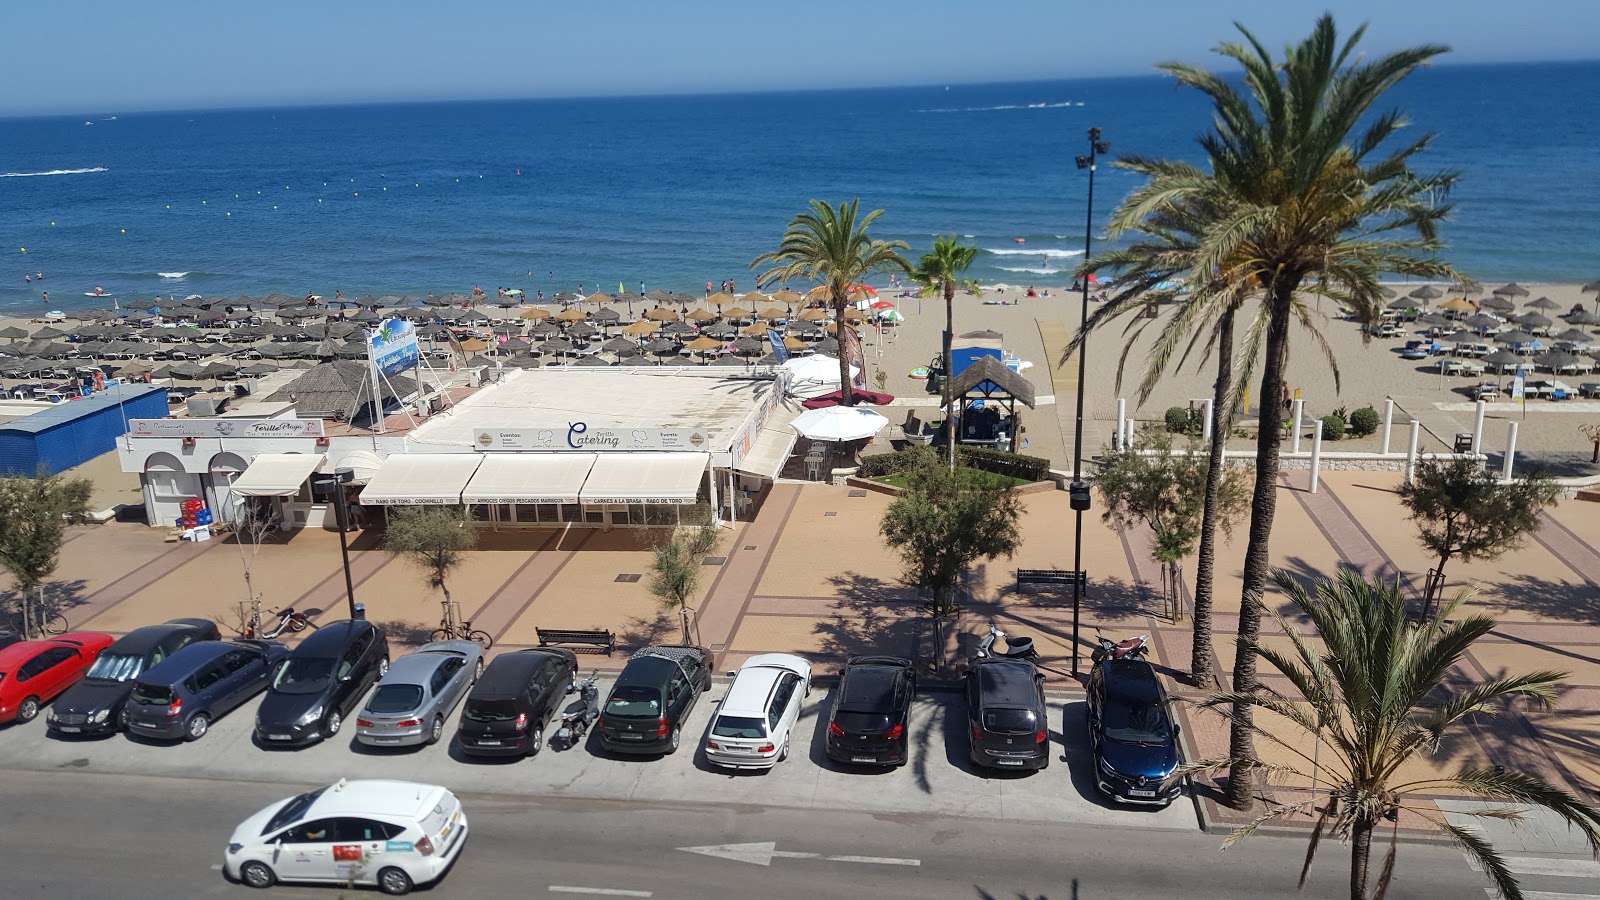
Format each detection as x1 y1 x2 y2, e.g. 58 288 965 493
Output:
355 641 483 746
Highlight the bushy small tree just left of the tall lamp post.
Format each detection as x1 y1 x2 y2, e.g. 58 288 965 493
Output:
878 455 1022 617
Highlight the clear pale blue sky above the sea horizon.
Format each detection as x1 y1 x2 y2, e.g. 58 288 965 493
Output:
0 0 1600 115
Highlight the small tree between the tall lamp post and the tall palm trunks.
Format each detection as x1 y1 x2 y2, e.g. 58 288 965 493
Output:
1094 429 1250 618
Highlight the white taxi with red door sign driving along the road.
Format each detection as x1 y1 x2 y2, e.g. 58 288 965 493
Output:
222 780 467 894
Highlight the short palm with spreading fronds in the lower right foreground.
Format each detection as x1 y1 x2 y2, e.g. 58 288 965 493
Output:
1186 569 1600 900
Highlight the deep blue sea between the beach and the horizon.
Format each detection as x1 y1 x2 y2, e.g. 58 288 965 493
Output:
0 62 1600 314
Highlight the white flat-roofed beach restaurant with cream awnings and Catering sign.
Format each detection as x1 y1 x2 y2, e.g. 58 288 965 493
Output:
118 367 795 528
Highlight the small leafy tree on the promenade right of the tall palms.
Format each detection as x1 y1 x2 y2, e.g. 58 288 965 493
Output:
1400 456 1562 615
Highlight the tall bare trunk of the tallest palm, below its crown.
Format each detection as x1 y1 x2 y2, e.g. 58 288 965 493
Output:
1227 286 1299 809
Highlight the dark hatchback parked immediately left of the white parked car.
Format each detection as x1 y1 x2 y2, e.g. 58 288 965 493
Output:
595 645 712 753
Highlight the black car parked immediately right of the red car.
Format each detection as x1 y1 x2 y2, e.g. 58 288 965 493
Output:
45 618 221 735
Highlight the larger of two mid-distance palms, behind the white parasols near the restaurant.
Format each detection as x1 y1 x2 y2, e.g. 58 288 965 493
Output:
750 197 910 407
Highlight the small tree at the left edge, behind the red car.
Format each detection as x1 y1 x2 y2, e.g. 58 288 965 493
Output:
0 469 94 636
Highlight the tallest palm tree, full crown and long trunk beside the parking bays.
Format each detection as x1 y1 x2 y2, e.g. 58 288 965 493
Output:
1083 14 1461 809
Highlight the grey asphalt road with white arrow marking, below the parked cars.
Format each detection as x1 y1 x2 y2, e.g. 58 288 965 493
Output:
0 769 1510 900
